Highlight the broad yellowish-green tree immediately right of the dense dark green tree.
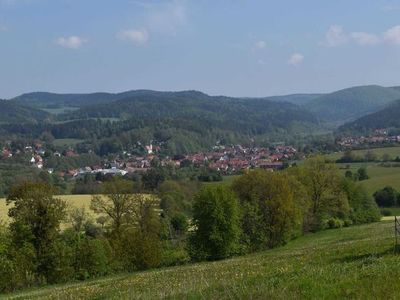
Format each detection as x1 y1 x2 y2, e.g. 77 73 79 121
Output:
233 170 299 251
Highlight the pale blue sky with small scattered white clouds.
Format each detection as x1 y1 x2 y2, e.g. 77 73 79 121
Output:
0 0 400 98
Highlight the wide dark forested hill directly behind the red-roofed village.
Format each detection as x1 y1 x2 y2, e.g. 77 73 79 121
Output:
2 91 320 155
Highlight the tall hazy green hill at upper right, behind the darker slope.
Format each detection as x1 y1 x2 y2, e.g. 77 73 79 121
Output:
305 85 400 124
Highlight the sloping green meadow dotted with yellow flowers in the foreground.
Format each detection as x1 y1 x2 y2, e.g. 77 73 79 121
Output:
8 221 400 299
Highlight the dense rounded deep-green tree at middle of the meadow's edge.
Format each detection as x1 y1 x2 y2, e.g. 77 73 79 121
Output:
189 185 240 260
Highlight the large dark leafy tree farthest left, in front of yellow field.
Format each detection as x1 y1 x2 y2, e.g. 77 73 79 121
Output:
7 182 66 282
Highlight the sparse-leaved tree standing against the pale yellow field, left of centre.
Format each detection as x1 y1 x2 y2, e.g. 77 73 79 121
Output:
90 177 135 235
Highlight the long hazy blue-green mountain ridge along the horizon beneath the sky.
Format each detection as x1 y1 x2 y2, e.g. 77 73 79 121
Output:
11 85 400 126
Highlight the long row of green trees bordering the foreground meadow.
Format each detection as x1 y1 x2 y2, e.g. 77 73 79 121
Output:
0 158 380 292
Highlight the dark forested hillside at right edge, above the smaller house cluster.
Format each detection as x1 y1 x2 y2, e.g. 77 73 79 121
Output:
338 100 400 134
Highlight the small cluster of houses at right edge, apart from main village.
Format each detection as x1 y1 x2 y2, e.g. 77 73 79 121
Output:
337 129 400 147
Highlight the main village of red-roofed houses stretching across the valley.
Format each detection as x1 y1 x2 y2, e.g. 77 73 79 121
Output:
1 143 297 178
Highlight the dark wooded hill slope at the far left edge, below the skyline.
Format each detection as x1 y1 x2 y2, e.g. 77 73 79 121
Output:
0 100 49 123
